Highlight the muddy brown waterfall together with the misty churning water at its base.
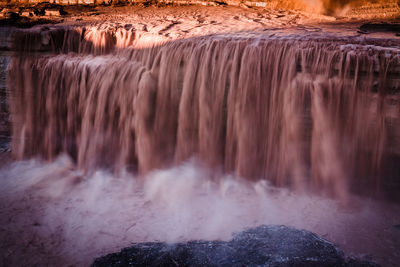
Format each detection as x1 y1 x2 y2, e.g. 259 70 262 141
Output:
0 21 400 266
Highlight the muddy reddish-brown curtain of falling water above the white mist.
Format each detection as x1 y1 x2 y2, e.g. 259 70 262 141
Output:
8 26 400 195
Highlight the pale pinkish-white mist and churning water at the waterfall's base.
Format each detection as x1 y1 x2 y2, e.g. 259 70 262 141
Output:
0 155 400 266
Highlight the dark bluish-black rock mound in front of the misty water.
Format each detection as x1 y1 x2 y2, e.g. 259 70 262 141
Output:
92 226 377 267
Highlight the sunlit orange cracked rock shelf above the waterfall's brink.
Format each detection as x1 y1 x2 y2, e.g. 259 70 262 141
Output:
0 0 400 43
